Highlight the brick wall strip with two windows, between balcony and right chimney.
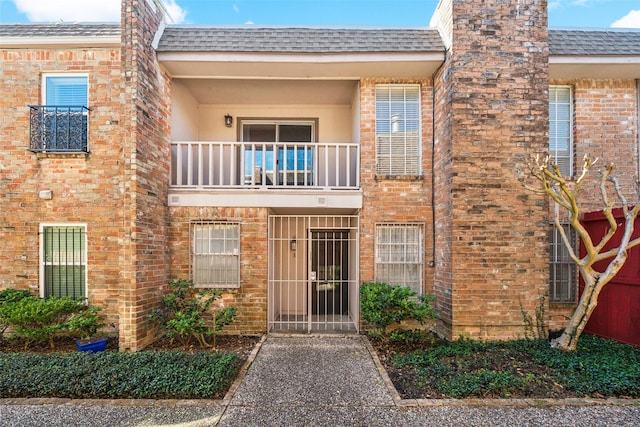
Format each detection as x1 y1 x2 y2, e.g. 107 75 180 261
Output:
360 79 433 293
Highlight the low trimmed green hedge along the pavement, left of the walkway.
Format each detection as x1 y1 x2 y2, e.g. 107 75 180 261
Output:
0 351 240 399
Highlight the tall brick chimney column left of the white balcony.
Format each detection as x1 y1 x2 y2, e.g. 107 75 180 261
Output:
120 0 171 351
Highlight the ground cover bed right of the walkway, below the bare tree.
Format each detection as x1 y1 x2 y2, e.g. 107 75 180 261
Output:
373 335 640 399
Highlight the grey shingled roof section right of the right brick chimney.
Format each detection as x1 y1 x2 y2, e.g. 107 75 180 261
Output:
549 29 640 55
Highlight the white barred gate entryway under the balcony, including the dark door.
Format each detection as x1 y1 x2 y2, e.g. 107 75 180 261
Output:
268 215 359 332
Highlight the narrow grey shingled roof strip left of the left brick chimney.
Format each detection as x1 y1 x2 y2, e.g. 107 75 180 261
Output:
0 22 120 38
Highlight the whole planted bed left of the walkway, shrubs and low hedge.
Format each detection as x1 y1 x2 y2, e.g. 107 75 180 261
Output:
0 281 259 399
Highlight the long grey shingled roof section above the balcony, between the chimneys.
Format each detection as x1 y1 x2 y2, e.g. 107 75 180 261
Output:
158 26 444 53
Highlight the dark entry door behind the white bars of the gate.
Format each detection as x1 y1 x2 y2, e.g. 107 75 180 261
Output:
308 230 349 330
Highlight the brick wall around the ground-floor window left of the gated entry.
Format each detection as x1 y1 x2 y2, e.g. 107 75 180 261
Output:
169 207 268 334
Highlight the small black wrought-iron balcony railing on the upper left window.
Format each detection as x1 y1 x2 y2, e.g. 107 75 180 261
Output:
29 105 89 153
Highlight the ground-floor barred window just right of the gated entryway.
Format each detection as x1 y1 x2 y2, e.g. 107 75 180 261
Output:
375 224 423 295
